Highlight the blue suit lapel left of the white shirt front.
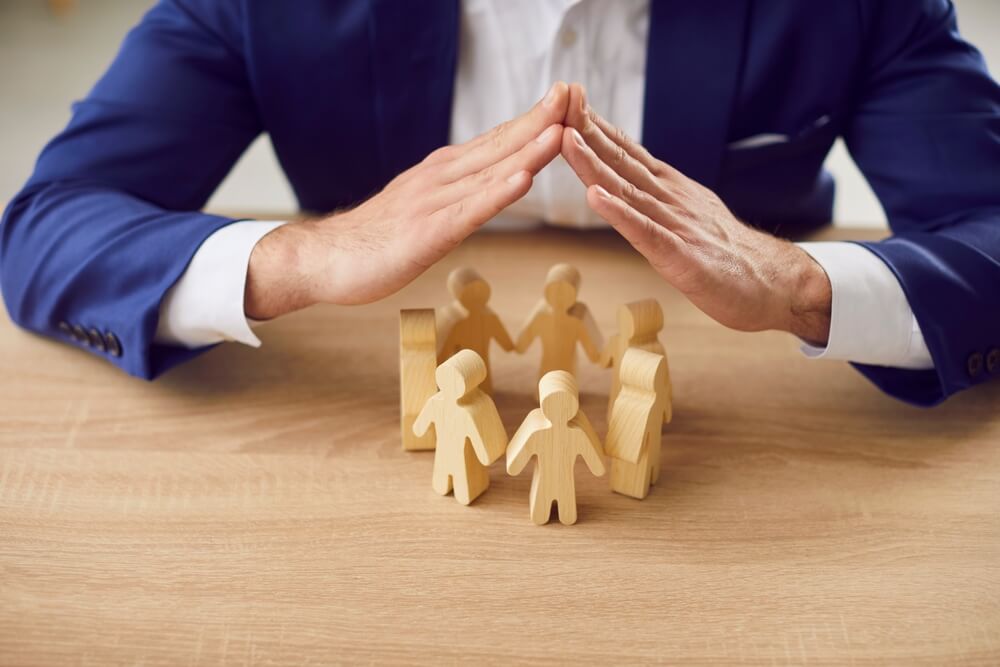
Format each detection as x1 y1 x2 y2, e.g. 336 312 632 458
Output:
369 0 459 182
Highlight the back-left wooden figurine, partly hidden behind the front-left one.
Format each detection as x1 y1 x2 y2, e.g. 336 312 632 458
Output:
438 268 514 394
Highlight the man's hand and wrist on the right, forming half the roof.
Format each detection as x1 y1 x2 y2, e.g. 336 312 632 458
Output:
562 84 832 345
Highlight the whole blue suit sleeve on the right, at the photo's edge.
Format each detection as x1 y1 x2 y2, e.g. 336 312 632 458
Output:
845 0 1000 406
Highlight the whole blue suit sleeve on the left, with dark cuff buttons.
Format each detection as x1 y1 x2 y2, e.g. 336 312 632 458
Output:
0 0 260 379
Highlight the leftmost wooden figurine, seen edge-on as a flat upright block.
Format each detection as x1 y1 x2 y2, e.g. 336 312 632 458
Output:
399 308 437 451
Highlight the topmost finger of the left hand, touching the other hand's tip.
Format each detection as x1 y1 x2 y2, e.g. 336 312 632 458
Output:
441 81 569 181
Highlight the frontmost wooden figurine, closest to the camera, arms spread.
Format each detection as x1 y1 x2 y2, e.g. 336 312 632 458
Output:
507 371 604 525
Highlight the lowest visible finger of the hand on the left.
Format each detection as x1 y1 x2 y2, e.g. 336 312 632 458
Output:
428 171 533 247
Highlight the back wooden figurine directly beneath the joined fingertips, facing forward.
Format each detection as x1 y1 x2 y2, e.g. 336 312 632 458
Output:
515 264 604 378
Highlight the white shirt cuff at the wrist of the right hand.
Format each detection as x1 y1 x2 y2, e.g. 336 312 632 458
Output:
798 242 934 369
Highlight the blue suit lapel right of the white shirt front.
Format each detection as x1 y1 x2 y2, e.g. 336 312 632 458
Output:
642 0 751 188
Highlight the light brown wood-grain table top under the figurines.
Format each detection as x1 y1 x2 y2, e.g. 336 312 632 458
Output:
0 231 1000 665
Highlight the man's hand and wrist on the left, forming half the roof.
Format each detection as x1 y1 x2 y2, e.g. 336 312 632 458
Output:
244 82 569 319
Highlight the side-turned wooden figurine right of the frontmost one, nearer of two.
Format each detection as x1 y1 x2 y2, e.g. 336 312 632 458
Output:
604 348 670 500
